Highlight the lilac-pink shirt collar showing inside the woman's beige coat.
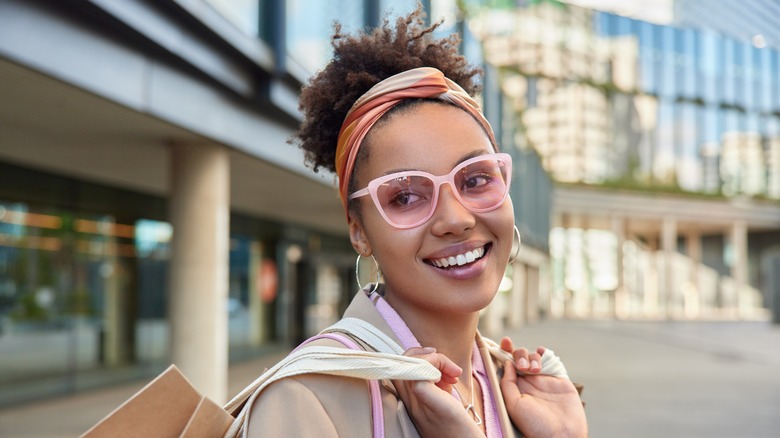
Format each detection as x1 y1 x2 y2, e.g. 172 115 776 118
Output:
369 292 503 438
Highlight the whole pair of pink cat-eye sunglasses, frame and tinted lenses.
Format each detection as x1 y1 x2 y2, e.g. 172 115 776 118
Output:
349 153 512 228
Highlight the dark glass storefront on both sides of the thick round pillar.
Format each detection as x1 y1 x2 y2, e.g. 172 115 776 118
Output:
0 162 356 406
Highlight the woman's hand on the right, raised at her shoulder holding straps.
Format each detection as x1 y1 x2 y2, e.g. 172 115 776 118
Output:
501 338 588 438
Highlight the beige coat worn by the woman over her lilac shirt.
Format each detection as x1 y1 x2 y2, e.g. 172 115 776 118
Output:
248 293 520 438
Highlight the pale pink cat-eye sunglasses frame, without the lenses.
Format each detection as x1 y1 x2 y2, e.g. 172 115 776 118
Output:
349 152 512 229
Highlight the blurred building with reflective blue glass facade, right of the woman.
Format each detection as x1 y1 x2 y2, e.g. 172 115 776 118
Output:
471 0 780 318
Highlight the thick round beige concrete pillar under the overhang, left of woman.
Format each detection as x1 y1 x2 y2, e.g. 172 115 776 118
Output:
168 144 230 404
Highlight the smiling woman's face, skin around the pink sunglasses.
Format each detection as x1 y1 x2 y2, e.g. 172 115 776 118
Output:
350 103 514 317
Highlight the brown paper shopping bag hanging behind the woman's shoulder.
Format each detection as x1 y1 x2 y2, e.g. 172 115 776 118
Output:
81 365 233 438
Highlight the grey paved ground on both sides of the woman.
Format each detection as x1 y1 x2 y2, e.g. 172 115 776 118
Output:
0 321 780 438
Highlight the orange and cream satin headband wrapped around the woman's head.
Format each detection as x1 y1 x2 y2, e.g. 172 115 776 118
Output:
336 67 496 219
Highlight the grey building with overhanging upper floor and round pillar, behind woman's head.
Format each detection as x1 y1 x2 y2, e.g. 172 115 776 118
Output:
0 0 551 406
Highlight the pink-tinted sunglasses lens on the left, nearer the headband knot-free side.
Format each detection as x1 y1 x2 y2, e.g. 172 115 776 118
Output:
377 175 434 226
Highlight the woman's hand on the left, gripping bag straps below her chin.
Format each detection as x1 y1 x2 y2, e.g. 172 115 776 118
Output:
393 348 484 437
